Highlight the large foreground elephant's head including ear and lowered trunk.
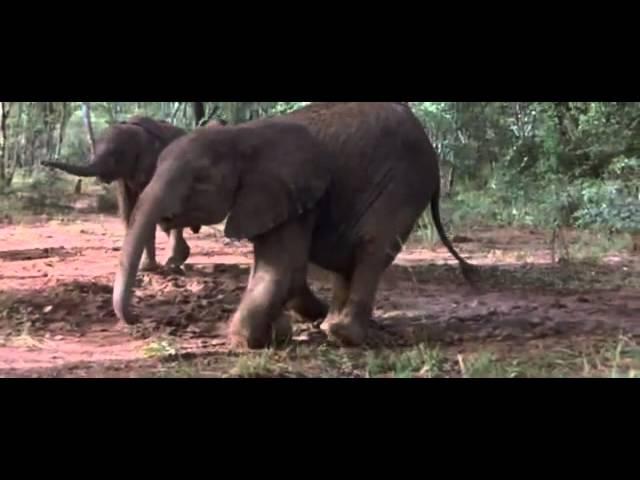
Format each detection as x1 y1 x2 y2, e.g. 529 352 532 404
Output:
113 120 333 323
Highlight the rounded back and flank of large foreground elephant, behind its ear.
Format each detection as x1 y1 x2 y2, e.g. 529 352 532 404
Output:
281 102 439 262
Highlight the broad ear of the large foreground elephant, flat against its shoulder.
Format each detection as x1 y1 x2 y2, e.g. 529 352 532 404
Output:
225 122 331 240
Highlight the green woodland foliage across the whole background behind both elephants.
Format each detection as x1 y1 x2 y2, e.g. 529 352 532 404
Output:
0 102 640 238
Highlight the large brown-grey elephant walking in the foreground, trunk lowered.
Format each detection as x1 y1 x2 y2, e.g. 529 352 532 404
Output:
113 102 474 348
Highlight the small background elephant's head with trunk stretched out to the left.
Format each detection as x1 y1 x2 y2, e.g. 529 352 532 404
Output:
42 116 185 183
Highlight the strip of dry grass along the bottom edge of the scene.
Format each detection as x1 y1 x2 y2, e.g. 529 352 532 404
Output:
140 338 640 379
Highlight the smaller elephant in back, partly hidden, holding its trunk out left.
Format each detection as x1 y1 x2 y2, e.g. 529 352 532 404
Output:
43 115 213 270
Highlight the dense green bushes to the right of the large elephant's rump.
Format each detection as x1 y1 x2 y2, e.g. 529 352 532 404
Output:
411 102 640 236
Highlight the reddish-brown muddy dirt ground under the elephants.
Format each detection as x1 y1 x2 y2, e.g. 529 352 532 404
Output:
0 215 640 377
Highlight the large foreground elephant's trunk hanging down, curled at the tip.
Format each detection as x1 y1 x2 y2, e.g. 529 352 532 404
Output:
112 192 168 325
